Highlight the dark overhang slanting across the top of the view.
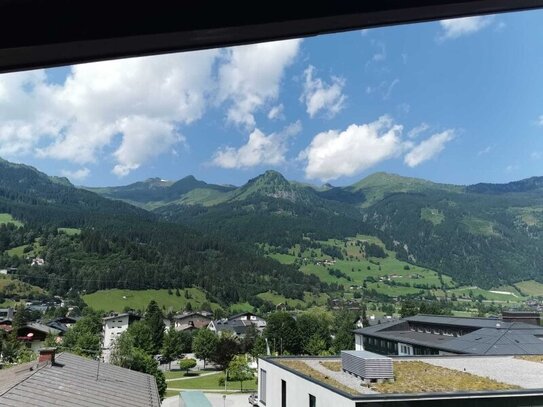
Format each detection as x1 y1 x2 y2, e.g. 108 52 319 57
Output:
0 0 543 72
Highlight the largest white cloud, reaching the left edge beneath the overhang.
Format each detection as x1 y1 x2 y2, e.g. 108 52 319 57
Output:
0 51 218 174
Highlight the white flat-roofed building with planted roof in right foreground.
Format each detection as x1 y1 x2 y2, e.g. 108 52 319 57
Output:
258 354 543 407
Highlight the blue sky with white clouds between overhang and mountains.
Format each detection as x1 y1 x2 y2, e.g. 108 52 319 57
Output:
0 11 543 186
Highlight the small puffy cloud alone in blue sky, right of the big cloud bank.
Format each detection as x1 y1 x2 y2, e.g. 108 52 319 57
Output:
300 65 345 118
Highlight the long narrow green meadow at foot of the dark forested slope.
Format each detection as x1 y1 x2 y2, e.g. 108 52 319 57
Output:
83 288 219 312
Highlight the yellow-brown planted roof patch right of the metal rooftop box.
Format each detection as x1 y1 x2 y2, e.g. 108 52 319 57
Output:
373 361 519 393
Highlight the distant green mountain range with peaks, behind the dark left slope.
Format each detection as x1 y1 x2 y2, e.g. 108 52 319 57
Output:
87 171 543 288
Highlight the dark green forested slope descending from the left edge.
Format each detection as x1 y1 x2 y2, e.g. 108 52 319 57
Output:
0 161 327 304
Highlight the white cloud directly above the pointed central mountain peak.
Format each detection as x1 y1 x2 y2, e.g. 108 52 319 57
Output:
212 121 302 168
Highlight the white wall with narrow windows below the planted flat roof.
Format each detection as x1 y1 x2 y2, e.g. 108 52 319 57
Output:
258 359 355 407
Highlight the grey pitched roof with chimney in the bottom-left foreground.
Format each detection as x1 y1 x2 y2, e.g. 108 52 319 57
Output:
0 353 160 407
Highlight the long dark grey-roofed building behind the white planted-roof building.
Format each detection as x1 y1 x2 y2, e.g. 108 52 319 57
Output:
354 315 543 356
